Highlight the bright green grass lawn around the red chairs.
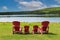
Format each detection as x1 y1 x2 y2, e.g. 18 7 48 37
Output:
0 22 60 40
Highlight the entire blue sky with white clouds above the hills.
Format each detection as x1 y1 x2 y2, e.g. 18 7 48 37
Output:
0 0 60 12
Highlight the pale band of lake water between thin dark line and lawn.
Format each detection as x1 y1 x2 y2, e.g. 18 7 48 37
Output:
0 17 60 22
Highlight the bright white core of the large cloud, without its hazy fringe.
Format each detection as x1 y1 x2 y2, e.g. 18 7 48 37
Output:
19 1 43 7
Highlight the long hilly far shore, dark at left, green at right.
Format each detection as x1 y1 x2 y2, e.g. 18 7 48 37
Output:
0 7 60 17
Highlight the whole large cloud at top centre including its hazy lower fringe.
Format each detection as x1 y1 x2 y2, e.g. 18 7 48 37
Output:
15 1 47 11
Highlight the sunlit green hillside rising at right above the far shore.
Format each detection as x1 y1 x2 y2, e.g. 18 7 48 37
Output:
33 7 60 14
